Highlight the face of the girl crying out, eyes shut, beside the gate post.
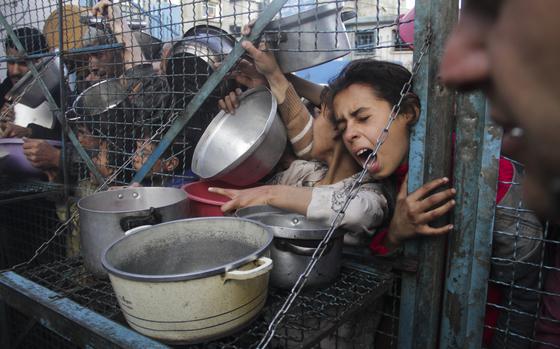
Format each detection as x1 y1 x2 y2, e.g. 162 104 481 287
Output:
333 83 410 179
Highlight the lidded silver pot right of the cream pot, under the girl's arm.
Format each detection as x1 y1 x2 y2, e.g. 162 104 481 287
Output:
235 206 344 289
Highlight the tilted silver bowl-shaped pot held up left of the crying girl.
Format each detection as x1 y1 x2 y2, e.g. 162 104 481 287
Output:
191 87 287 186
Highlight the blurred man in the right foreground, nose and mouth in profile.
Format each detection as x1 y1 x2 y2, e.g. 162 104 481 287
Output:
426 0 560 348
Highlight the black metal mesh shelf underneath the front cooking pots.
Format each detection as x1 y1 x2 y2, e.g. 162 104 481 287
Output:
7 254 392 349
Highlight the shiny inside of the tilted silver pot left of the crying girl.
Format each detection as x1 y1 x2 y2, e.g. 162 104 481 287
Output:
195 90 273 178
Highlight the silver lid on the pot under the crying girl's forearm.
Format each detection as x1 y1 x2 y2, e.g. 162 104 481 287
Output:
235 206 344 240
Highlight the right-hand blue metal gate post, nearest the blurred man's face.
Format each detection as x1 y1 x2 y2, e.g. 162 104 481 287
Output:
440 93 501 348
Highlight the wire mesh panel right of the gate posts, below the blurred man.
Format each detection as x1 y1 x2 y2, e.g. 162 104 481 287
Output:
484 158 560 348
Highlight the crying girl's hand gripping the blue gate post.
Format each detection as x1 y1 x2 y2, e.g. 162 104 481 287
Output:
385 176 456 248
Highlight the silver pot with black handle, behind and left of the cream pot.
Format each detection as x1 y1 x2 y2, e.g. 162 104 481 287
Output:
78 187 188 277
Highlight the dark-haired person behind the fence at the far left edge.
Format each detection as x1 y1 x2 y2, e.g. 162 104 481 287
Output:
0 27 60 140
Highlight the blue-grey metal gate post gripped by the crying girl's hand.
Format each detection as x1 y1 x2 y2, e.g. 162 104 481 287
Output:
399 0 459 349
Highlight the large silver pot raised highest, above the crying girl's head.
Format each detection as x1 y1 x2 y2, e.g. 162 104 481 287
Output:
265 4 350 73
